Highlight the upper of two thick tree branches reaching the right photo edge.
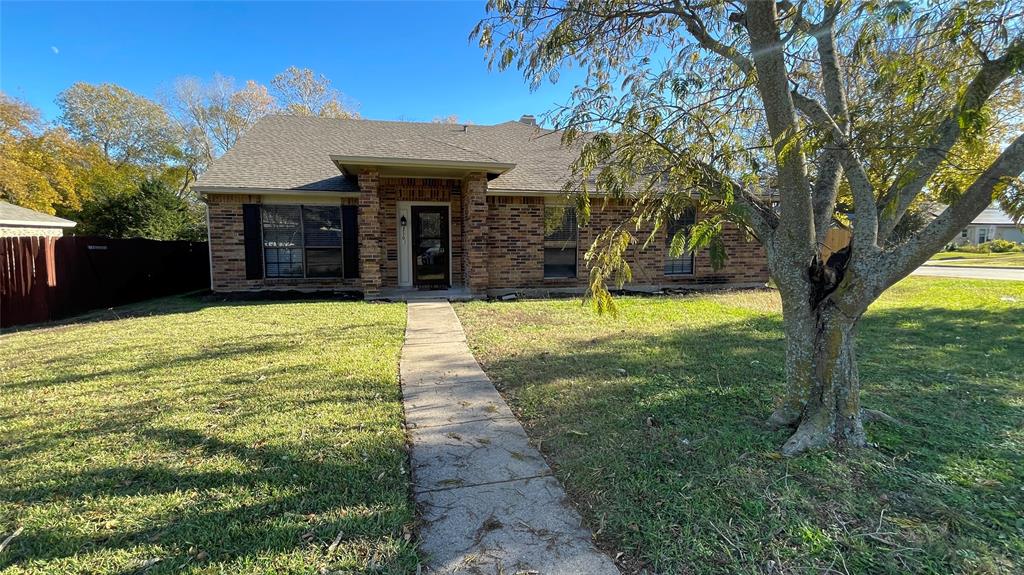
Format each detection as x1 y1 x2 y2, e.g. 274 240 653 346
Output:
879 37 1024 238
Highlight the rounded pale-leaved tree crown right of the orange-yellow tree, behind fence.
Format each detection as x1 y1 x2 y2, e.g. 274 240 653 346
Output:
57 82 181 165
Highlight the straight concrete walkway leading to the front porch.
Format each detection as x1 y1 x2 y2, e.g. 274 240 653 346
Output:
401 301 618 575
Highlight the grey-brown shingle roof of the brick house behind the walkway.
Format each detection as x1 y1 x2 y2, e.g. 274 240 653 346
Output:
197 116 579 191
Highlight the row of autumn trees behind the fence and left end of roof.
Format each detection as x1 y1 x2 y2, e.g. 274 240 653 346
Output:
0 67 357 240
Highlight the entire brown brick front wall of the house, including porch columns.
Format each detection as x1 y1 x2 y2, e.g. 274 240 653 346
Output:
207 188 768 297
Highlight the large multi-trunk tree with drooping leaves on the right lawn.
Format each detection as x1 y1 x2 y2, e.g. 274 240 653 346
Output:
474 0 1024 455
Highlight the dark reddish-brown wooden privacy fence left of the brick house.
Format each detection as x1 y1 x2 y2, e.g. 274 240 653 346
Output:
0 236 210 327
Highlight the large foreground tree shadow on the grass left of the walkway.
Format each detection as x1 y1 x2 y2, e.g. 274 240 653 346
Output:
0 421 412 573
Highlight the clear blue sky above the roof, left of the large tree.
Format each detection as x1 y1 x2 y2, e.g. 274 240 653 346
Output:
0 0 579 124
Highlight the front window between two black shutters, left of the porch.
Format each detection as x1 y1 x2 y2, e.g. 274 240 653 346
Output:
262 206 342 277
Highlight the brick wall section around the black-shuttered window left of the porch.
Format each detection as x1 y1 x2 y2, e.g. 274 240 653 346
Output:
206 194 361 292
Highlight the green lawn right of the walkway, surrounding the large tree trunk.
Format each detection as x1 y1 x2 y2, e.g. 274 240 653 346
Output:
457 278 1024 574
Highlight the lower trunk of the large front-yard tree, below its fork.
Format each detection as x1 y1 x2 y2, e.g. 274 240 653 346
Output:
769 290 866 456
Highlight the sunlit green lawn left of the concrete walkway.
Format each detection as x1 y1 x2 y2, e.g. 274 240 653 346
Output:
0 298 418 574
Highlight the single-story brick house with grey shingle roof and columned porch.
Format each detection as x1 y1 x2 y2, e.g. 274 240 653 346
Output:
196 116 768 299
